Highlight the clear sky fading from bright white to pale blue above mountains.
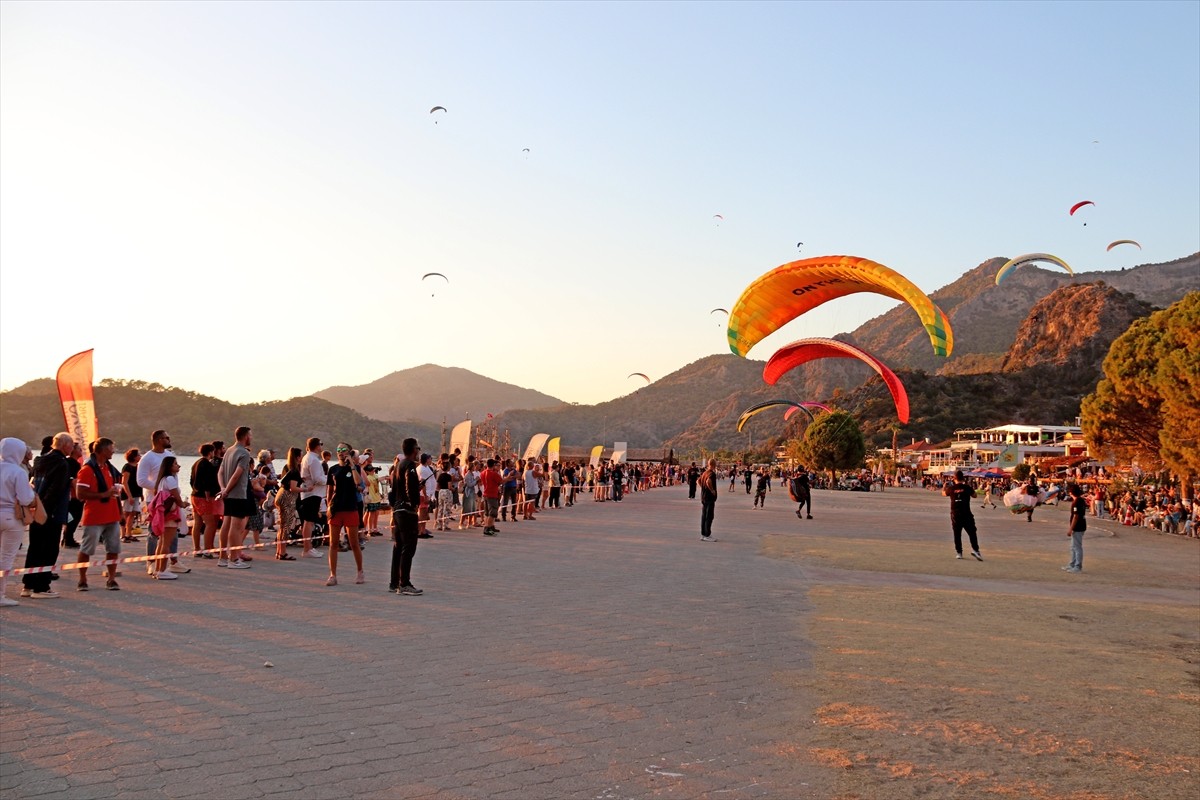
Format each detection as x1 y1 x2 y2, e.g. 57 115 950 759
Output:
0 1 1200 403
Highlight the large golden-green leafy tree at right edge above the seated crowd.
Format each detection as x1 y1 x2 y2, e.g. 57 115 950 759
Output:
1081 291 1200 486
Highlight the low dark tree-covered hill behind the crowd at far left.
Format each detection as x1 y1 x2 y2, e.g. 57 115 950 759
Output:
0 379 440 458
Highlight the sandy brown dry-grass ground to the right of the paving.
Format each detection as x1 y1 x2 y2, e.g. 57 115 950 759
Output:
764 527 1200 800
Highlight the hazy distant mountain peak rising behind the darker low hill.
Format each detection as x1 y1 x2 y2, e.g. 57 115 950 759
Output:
313 363 564 426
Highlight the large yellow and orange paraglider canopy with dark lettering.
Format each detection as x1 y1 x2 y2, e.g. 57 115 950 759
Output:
727 255 954 356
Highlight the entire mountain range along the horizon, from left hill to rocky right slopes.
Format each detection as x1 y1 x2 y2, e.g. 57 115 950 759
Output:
0 253 1200 453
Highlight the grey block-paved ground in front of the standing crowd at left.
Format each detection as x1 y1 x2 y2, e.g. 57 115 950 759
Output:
0 487 828 800
